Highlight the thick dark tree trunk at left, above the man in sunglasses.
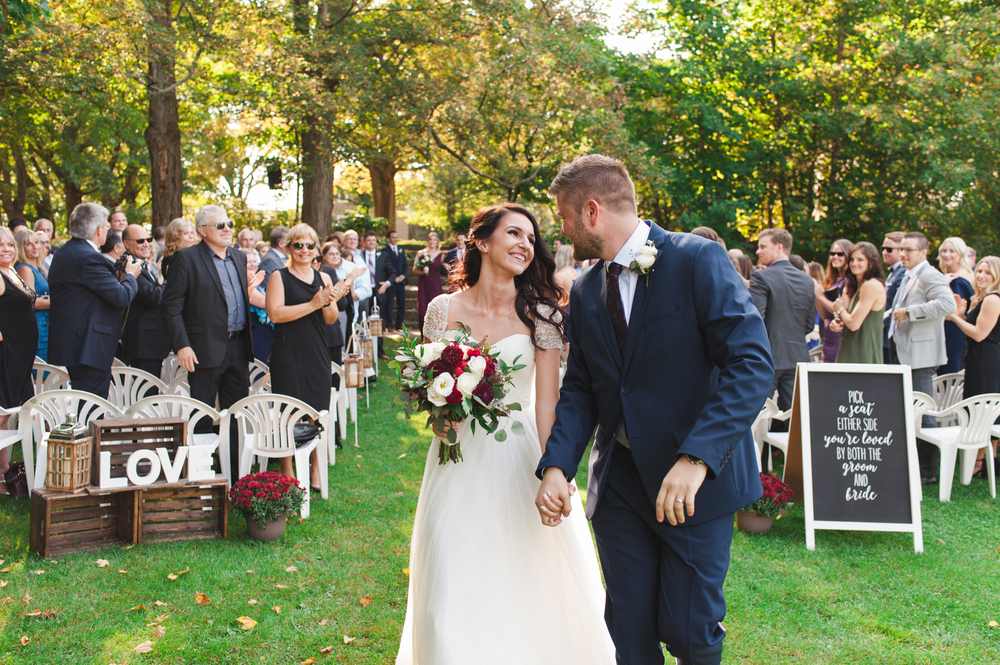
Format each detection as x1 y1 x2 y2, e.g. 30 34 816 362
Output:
145 0 184 228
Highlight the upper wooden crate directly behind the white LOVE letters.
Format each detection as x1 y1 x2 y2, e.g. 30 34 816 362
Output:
90 418 187 486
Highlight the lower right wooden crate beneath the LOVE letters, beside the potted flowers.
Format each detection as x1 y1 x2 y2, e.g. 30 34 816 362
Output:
136 477 229 543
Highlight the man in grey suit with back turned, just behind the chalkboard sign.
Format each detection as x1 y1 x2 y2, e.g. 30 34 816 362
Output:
750 229 816 411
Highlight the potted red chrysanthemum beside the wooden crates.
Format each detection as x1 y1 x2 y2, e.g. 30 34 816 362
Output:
229 471 306 540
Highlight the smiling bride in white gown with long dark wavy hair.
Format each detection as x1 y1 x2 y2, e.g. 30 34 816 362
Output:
396 203 615 665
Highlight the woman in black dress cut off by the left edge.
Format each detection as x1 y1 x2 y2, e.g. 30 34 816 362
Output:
0 226 38 477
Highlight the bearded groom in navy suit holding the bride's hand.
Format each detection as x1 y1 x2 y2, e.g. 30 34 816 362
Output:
535 155 774 665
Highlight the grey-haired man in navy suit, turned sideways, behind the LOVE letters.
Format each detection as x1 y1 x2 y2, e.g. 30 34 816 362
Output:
49 203 141 399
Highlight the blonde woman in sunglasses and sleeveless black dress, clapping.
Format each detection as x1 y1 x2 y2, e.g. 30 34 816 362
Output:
267 224 348 491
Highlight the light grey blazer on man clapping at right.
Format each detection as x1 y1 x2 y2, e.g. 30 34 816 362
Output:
886 262 955 369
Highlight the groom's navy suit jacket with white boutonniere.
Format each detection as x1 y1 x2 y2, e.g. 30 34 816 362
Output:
537 224 774 525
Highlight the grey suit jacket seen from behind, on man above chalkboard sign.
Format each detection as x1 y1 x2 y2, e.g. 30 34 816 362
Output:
750 261 816 371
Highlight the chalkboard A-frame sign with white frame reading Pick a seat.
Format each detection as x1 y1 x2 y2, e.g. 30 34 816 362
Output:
786 363 924 552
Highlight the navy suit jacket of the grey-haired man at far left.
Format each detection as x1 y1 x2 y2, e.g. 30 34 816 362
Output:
48 238 139 371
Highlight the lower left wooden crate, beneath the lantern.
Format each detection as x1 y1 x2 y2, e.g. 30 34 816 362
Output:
28 489 139 558
